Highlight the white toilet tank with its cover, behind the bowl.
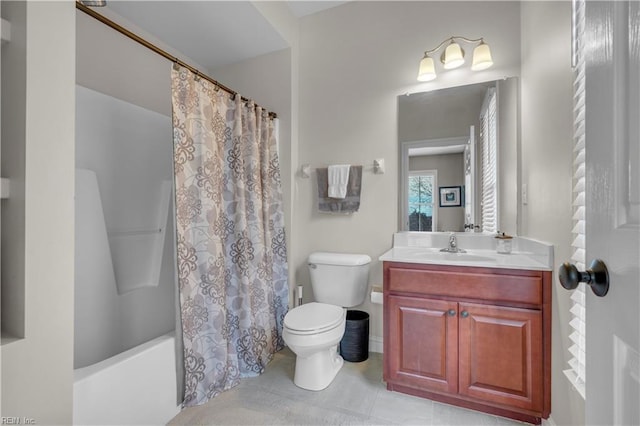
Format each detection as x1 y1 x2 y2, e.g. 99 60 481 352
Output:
308 252 371 308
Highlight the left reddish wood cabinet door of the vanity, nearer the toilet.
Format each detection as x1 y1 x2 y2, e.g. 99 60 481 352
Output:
385 295 458 393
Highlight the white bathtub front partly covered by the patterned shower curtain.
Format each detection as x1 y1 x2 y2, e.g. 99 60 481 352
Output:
73 333 180 425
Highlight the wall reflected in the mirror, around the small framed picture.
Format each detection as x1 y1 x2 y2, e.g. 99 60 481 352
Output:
409 153 464 232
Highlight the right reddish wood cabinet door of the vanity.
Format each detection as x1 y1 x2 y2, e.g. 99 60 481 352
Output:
459 303 543 411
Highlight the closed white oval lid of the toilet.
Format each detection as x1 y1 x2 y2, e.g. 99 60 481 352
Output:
284 302 344 333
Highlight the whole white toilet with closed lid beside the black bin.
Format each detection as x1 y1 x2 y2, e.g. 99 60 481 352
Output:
282 252 371 391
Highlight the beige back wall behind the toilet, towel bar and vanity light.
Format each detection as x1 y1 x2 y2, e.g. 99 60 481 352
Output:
291 1 520 341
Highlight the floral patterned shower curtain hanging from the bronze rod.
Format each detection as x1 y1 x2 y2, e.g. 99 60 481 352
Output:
172 66 289 406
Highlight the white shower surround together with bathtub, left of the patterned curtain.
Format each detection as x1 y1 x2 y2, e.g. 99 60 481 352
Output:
74 86 180 424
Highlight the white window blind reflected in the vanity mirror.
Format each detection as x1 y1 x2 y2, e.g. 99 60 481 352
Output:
480 88 498 233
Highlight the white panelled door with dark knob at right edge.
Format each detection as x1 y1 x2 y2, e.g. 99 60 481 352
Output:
585 1 640 425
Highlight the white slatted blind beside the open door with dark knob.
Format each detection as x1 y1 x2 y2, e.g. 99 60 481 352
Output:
564 0 586 398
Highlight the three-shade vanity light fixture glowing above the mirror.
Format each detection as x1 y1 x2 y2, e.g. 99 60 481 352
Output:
418 36 493 81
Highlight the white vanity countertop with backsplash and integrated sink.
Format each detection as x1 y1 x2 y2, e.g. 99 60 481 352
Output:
378 232 553 271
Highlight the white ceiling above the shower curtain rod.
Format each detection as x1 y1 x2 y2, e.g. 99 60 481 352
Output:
106 0 347 70
